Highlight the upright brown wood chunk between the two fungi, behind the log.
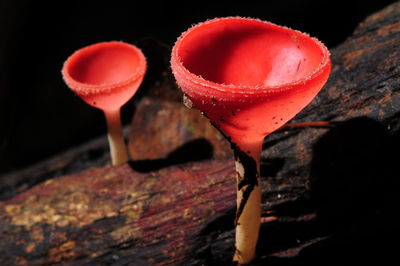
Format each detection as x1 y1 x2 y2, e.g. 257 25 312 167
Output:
129 97 233 160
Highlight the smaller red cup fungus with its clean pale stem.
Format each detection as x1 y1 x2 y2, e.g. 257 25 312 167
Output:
62 41 146 165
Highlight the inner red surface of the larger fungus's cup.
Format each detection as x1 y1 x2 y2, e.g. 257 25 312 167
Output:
178 17 324 87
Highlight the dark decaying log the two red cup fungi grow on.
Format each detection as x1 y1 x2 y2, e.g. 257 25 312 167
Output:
0 2 400 265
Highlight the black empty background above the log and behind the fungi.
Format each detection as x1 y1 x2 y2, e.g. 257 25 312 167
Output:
0 0 394 174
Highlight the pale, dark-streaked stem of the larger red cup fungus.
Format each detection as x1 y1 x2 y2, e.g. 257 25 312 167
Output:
233 141 262 265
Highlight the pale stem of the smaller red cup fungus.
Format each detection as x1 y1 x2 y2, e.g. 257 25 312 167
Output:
104 108 128 166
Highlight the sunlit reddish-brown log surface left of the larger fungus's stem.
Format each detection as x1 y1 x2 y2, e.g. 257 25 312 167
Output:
0 160 236 265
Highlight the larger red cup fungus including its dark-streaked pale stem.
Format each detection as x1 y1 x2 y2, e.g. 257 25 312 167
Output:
171 17 331 264
